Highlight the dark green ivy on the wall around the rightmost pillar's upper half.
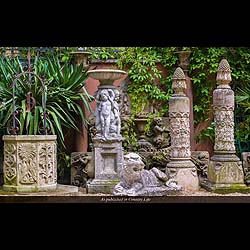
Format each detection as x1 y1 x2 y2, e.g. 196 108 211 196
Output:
189 47 250 149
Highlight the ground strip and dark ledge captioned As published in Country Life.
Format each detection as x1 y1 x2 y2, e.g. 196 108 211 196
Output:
0 184 250 204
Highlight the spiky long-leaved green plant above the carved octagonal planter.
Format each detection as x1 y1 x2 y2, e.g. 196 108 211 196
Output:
0 54 93 178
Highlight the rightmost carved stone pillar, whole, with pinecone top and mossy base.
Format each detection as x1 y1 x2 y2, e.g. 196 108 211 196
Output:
204 59 246 192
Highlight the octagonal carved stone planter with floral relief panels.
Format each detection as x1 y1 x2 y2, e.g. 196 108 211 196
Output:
3 135 57 192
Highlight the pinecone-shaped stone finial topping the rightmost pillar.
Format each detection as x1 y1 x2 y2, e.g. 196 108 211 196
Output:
216 59 232 88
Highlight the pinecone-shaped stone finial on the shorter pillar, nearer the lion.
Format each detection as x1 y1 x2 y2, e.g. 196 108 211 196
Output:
172 67 187 95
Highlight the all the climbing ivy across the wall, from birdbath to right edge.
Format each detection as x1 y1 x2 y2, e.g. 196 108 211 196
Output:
65 47 250 151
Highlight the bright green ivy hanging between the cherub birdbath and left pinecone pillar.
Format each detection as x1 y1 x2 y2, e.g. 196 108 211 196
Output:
118 47 175 114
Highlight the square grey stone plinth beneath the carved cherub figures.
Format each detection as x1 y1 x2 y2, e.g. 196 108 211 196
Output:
87 139 123 193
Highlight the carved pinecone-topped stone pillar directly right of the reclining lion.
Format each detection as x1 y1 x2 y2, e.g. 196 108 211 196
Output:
166 67 199 191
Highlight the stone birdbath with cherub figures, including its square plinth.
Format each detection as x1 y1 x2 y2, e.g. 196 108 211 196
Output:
87 69 126 194
